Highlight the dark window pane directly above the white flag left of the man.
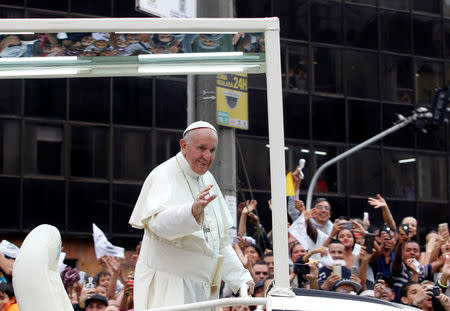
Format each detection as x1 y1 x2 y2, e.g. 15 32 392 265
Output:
68 182 109 234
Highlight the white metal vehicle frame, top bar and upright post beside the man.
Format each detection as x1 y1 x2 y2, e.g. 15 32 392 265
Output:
0 17 294 310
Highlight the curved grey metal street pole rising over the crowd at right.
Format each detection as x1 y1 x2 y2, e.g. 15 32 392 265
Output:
306 117 417 211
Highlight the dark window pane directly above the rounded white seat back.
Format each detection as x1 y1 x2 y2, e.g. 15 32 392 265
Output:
23 179 66 230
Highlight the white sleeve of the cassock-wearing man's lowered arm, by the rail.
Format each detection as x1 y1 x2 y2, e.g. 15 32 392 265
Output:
220 244 253 293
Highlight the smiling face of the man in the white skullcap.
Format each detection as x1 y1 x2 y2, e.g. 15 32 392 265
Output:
180 128 217 175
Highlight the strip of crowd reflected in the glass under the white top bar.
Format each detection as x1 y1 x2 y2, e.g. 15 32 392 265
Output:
0 32 265 57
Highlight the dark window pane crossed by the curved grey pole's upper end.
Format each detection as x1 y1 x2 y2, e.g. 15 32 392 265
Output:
382 104 414 148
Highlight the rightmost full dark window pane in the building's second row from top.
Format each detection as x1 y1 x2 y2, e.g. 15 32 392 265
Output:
413 15 443 57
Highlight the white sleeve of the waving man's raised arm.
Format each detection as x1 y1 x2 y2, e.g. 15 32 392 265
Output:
147 204 201 240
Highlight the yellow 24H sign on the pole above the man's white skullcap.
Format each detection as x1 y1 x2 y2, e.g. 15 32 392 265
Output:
216 74 248 130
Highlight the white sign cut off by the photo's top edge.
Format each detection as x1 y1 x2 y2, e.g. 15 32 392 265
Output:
136 0 197 18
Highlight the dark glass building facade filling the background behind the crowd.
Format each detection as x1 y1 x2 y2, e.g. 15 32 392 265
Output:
0 0 450 247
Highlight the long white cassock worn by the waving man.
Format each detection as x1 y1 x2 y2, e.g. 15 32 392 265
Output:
129 152 252 310
